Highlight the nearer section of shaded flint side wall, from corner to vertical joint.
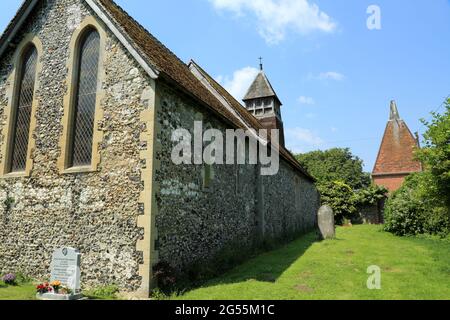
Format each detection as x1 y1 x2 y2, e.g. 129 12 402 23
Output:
156 82 256 270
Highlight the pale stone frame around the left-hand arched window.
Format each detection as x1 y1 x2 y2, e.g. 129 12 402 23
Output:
0 33 44 179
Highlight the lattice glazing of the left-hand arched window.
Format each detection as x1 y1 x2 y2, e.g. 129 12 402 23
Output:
8 45 38 172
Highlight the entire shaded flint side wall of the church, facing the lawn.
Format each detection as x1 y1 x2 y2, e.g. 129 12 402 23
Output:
156 82 319 270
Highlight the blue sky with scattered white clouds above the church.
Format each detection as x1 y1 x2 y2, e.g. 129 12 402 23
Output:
0 0 450 171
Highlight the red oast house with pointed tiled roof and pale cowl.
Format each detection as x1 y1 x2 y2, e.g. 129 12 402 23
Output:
372 101 422 192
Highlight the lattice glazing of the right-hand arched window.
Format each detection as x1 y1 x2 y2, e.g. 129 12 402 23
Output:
69 29 100 167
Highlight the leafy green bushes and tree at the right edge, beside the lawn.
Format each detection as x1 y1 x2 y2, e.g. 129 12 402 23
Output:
385 99 450 236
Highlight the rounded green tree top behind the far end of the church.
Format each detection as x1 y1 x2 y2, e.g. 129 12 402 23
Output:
297 148 370 190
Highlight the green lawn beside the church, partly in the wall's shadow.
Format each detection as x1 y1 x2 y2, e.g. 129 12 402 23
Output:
176 226 450 300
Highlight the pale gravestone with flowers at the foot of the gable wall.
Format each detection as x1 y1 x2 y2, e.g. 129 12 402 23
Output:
38 247 82 300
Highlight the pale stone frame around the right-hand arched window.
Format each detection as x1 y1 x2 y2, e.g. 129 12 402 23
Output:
58 16 107 174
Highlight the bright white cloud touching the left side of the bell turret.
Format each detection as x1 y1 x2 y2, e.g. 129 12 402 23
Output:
216 67 259 101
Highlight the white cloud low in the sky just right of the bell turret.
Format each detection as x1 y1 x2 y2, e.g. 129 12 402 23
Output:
285 127 325 153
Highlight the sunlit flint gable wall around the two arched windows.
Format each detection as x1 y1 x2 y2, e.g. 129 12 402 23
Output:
0 0 150 291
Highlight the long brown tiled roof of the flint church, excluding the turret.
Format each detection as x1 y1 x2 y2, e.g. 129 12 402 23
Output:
0 0 313 180
